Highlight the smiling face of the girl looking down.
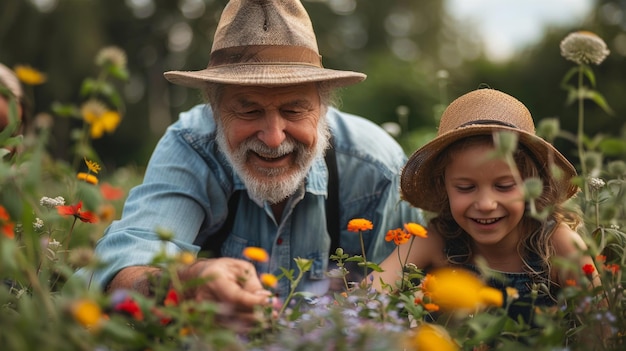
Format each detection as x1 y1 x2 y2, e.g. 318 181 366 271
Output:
445 144 525 249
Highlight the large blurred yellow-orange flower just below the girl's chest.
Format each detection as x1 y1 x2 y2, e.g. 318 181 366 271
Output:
422 268 503 310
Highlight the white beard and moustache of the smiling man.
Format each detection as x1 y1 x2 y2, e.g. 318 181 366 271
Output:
216 116 330 204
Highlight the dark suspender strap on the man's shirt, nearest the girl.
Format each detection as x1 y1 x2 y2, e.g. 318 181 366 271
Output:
324 136 341 255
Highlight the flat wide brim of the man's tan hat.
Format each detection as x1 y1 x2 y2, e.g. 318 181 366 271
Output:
164 63 366 89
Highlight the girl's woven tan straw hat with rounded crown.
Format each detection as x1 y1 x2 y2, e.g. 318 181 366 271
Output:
400 89 578 212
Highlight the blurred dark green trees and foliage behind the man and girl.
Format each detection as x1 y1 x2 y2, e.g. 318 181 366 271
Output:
0 0 626 170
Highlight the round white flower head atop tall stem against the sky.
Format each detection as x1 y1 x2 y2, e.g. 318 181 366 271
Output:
560 31 610 65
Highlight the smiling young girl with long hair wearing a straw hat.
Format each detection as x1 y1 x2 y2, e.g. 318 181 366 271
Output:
373 89 599 320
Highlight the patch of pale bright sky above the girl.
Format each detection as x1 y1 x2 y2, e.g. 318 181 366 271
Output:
446 0 594 61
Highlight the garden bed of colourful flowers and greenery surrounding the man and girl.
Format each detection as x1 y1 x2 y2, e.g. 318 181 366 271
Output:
0 32 626 351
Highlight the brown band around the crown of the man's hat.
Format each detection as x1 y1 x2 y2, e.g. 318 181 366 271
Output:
209 45 322 68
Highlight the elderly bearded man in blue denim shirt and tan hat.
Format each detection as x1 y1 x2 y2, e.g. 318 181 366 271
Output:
79 0 421 322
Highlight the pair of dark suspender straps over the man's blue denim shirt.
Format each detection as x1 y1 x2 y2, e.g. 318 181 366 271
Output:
200 137 341 257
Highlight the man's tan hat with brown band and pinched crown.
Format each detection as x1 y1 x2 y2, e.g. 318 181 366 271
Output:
165 0 365 88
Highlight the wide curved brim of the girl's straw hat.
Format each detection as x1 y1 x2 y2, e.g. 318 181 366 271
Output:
400 125 578 212
